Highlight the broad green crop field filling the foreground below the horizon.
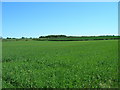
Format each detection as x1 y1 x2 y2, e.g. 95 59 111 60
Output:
2 40 118 88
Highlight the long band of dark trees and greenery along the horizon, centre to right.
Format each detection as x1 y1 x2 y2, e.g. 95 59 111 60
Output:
37 35 120 41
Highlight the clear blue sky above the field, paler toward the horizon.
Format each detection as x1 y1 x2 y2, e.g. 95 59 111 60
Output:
2 2 118 38
